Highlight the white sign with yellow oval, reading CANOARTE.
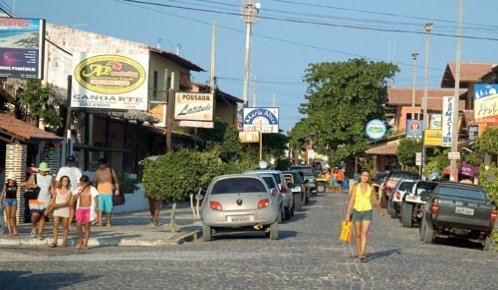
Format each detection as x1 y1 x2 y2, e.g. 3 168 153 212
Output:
71 53 149 111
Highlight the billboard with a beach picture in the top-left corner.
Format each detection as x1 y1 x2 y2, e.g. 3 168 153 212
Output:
0 17 45 79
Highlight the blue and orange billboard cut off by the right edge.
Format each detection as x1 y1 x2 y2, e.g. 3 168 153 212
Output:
474 84 498 125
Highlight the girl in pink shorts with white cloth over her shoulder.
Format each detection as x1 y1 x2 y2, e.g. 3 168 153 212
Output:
74 175 99 250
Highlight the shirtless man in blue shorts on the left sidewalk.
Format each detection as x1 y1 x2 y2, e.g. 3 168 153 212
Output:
93 159 119 227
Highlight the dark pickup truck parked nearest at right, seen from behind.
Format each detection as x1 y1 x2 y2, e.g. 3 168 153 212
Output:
419 182 497 250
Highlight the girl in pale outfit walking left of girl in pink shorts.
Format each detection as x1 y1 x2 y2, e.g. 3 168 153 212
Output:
45 176 71 248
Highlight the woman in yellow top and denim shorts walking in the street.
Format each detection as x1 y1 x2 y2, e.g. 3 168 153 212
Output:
345 169 385 261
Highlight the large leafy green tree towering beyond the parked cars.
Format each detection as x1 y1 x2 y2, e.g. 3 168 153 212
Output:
300 59 398 161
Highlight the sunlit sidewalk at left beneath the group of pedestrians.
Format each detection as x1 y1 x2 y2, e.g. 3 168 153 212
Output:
0 203 202 247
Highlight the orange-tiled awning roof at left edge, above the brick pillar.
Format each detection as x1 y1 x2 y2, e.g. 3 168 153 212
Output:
0 113 63 143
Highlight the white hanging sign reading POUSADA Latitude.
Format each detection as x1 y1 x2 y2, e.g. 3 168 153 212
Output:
175 93 214 122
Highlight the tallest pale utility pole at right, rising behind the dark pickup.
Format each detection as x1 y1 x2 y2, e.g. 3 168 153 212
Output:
450 0 463 181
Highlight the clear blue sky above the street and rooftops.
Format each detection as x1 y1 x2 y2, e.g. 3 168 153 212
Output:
6 0 498 132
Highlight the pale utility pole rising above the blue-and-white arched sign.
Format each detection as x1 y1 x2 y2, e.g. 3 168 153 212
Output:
242 0 261 107
